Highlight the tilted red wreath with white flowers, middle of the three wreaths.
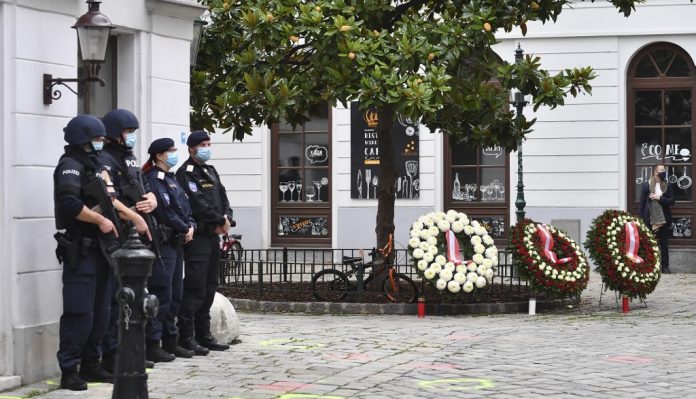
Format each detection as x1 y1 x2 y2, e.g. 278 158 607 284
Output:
510 219 590 296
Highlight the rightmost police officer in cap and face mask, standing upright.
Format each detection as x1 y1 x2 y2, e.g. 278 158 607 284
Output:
176 130 232 354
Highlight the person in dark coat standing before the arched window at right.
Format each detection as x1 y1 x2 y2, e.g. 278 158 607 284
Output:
640 164 674 273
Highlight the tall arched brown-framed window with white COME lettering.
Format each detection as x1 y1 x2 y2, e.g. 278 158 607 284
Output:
627 43 696 244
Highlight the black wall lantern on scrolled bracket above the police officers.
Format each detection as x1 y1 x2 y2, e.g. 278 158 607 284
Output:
43 0 114 105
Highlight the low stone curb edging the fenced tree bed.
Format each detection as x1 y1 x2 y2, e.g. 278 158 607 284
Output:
228 298 566 315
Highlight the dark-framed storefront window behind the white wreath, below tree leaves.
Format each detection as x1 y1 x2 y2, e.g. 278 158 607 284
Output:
444 136 509 245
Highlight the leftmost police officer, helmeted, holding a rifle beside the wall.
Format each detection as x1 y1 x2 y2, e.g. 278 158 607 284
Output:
53 115 149 391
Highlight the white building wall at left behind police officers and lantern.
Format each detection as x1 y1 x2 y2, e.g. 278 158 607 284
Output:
0 0 204 390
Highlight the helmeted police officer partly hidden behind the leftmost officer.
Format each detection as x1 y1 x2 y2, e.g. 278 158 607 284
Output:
99 109 157 373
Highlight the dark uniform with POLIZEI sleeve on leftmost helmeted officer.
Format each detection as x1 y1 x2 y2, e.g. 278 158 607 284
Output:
53 146 112 389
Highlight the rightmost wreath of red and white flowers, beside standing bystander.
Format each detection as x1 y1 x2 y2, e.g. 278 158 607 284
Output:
585 209 661 298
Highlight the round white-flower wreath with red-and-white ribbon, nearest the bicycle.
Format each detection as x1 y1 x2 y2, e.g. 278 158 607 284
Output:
408 210 498 294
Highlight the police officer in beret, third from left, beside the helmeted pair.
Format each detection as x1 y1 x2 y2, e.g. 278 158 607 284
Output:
143 138 196 363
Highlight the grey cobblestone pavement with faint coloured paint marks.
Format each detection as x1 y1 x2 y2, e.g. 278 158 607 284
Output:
0 274 696 399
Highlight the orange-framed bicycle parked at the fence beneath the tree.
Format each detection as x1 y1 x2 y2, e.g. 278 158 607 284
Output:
311 235 418 303
